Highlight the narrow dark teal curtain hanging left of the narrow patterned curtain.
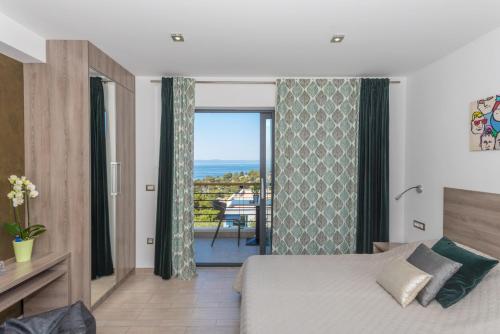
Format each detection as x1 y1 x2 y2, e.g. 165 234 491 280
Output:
154 78 174 279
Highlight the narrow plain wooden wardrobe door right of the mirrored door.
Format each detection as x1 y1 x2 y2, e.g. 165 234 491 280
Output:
115 84 135 282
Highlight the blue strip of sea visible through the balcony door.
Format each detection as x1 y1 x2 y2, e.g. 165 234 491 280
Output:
193 160 259 180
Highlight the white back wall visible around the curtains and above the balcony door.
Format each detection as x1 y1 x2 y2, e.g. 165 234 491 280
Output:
135 77 406 268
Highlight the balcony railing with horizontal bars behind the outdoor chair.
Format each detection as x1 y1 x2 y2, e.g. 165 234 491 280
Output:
194 181 260 230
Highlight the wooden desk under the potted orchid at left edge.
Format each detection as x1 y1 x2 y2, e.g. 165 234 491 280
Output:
0 253 70 315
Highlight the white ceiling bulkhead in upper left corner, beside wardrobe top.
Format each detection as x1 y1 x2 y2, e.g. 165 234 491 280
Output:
0 13 45 63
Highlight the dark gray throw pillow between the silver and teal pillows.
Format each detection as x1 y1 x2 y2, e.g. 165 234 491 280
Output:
407 244 462 306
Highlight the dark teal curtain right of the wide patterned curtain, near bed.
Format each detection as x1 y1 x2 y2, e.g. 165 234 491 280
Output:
356 79 389 253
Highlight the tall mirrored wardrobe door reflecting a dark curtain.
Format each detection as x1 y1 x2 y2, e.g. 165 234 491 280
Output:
89 69 119 305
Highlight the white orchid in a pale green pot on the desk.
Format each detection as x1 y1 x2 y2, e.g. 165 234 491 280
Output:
5 175 46 262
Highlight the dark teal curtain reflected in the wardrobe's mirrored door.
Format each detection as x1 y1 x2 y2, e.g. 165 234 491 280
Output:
90 77 113 279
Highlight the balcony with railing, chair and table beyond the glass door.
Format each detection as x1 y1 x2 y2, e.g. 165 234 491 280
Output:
194 181 260 264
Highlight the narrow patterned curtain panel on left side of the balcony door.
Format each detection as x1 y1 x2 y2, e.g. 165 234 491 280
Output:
172 78 196 279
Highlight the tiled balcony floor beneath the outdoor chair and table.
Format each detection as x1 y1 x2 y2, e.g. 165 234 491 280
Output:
194 238 259 263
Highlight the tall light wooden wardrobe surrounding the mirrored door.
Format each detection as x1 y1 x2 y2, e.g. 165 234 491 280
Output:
24 40 136 307
